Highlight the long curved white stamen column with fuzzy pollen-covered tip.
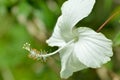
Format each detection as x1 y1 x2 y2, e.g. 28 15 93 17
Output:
23 39 75 62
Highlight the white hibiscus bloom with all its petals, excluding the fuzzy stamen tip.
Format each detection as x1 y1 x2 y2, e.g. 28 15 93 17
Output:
47 0 113 78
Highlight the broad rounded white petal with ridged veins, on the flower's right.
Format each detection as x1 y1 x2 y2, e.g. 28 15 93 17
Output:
74 27 113 68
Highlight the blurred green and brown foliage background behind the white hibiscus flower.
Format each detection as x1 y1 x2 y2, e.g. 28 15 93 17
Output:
0 0 120 80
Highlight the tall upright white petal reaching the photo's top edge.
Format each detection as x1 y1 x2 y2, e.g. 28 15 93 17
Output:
58 0 95 41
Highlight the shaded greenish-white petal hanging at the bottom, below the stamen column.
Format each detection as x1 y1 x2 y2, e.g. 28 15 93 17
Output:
60 44 87 79
